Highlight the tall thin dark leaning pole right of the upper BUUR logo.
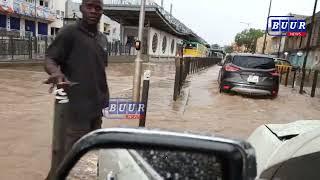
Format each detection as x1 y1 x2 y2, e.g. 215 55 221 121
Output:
299 0 318 94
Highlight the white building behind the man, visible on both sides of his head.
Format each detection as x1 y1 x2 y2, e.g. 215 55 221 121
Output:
0 0 120 41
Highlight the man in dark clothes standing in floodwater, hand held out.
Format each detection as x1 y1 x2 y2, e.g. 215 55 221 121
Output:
45 0 109 179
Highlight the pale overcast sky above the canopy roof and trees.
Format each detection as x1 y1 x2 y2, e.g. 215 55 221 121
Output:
155 0 320 45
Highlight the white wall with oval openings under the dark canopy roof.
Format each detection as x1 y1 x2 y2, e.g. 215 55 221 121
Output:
149 28 182 57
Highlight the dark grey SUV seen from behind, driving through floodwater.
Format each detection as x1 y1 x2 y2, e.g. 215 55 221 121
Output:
218 54 279 97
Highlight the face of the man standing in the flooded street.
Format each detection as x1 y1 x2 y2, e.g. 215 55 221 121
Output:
80 0 103 25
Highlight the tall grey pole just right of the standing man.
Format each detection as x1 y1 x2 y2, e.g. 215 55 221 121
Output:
132 0 146 102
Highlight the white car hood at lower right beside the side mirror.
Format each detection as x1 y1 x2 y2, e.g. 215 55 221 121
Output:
248 120 320 177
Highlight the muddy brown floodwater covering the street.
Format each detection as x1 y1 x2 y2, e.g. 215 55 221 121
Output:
0 63 320 180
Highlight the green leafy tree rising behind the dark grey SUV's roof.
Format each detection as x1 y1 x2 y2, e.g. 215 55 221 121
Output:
235 28 264 53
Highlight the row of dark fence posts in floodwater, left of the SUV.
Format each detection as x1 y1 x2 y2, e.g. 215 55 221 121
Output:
173 58 222 101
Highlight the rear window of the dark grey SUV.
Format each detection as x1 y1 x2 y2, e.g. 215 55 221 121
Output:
232 56 275 69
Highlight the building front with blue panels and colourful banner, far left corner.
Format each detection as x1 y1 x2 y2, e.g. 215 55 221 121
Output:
0 0 60 36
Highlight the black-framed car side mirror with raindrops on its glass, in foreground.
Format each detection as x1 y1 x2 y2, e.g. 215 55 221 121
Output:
55 128 257 180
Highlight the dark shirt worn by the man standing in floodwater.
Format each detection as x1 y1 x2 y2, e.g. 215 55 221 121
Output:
47 22 109 120
